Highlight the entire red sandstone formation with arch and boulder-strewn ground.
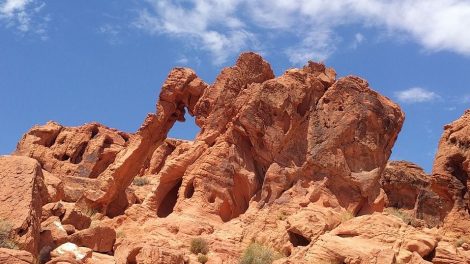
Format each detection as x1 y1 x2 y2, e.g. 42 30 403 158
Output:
0 53 470 264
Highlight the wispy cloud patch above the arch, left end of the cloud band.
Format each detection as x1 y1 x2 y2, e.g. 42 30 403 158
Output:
135 0 255 64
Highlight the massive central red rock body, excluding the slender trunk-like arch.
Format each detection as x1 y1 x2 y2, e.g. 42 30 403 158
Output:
140 54 403 224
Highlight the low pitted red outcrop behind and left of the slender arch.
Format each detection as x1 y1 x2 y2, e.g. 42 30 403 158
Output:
15 122 130 178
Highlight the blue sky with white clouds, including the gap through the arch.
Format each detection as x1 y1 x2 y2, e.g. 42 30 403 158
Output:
0 0 470 171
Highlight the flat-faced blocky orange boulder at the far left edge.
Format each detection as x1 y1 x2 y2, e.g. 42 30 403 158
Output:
0 156 46 254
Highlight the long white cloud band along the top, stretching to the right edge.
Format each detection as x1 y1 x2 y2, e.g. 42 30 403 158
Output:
137 0 470 63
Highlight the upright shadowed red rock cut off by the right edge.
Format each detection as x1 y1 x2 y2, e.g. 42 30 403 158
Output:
432 110 470 212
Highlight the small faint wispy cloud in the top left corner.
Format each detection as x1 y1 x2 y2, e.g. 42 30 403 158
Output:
0 0 50 39
